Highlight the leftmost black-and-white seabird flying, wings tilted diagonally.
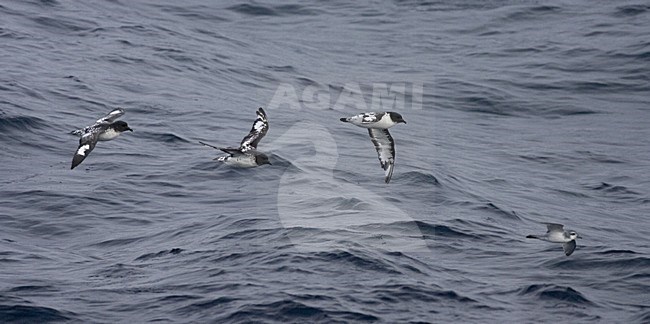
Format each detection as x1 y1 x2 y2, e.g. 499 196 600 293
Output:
70 108 133 169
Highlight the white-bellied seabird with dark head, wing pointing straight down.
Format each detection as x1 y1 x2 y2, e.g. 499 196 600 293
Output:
341 111 406 183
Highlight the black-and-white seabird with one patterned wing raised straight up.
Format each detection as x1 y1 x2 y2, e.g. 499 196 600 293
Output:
199 108 271 168
